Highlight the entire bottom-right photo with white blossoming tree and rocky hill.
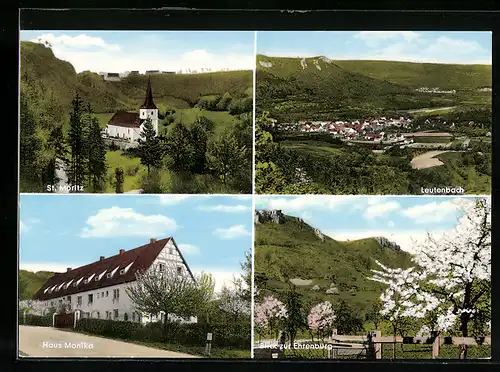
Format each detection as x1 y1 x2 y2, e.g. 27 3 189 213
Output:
253 195 492 360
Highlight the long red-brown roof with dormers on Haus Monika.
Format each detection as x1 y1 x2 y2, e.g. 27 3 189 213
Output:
33 237 194 301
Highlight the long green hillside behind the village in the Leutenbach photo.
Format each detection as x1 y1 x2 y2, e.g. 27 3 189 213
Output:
256 55 491 121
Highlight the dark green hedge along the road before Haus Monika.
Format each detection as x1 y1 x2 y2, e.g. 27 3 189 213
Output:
76 318 251 349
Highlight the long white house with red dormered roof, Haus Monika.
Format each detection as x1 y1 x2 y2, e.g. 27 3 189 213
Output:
34 237 197 323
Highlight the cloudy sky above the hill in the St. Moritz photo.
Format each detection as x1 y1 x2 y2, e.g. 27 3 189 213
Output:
20 30 255 73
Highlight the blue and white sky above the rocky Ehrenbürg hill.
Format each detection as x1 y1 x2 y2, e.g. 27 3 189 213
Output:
255 195 486 253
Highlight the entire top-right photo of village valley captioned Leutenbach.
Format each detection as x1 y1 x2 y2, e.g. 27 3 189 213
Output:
255 31 492 196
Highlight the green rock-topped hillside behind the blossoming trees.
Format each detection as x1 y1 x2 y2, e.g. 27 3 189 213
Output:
255 212 411 313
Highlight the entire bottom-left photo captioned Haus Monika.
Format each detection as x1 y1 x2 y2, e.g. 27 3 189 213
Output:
18 194 253 359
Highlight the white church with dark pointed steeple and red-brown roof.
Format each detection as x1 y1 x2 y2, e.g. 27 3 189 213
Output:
104 78 159 143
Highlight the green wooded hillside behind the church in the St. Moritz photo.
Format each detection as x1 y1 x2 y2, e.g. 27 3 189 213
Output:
21 41 252 113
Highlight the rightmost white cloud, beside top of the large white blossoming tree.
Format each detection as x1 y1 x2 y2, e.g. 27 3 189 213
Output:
401 199 465 224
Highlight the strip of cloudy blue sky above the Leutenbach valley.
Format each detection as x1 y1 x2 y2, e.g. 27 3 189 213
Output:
257 31 492 65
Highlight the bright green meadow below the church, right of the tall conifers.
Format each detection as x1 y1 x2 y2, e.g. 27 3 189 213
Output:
106 150 170 193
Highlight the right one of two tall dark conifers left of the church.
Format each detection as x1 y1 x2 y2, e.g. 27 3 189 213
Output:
87 117 107 192
